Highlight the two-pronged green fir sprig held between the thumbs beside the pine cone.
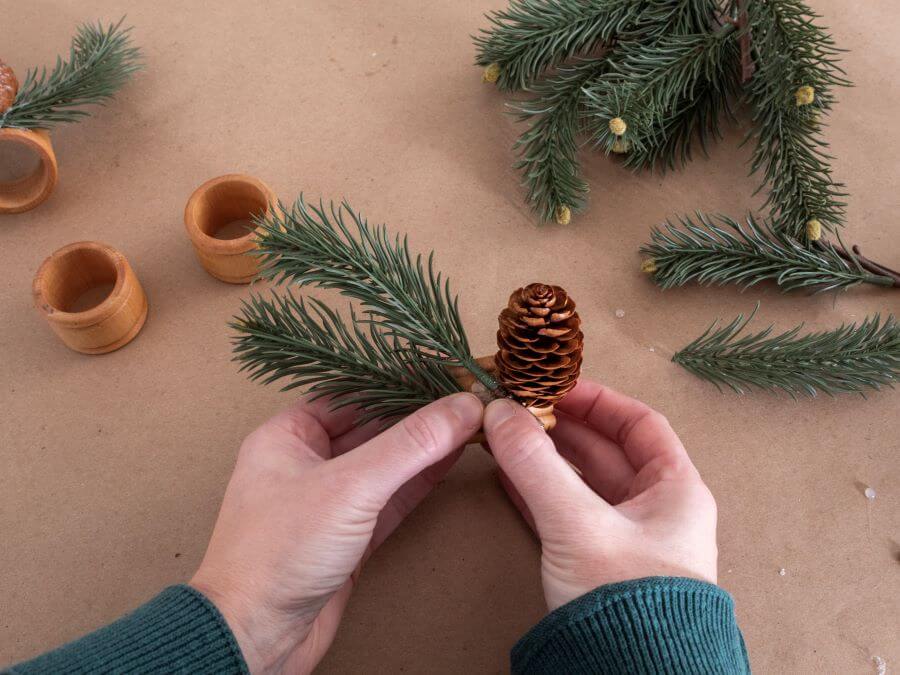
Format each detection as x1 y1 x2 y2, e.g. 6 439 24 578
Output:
232 196 503 421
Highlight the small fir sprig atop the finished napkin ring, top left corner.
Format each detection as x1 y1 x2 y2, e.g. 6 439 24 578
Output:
0 18 141 129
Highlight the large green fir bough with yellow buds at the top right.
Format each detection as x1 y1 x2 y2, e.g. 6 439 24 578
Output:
475 0 849 239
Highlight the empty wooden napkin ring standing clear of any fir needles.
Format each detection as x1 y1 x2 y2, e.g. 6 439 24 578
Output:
32 241 147 354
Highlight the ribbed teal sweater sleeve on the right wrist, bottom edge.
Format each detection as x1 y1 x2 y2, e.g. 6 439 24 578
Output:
512 577 750 675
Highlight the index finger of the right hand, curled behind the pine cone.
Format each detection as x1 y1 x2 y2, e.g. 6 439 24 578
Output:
556 380 687 471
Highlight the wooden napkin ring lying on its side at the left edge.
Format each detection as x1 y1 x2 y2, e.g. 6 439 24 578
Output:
0 129 59 213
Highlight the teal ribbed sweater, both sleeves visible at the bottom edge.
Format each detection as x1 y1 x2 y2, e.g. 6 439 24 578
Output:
3 577 750 675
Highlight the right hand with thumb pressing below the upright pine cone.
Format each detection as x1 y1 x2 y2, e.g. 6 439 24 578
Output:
484 381 718 611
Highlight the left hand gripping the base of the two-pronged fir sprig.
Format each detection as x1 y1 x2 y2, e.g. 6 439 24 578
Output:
190 394 482 673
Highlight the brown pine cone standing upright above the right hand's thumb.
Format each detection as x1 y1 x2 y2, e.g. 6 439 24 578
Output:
495 284 584 408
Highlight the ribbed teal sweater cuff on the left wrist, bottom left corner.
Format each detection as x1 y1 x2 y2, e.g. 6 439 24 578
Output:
7 586 247 675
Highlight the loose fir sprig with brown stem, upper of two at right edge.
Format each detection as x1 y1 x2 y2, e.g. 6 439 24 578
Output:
641 213 894 292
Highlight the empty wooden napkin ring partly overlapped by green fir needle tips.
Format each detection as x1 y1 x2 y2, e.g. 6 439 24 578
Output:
184 174 276 284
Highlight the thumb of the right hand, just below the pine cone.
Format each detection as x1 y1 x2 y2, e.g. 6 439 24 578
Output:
484 399 596 533
